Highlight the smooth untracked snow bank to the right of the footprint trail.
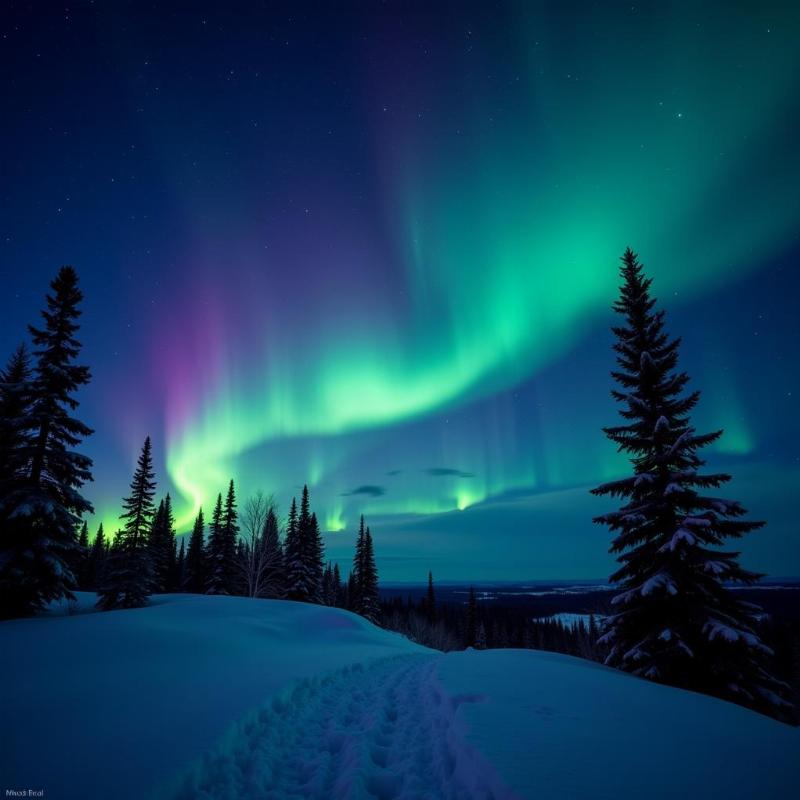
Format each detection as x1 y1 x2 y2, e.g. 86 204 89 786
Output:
439 650 800 800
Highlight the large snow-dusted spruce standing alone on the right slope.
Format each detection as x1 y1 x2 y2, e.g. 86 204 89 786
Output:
593 249 786 714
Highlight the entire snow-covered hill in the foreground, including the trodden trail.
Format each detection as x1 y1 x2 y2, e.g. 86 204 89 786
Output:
0 595 800 800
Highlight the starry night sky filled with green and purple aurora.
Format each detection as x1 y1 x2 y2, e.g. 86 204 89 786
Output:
0 0 800 580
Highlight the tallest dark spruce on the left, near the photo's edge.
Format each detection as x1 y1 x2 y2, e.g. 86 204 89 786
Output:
0 267 93 616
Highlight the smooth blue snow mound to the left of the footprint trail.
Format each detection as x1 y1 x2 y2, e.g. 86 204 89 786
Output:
0 593 429 800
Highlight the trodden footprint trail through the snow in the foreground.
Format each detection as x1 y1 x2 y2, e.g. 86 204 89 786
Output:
164 655 511 800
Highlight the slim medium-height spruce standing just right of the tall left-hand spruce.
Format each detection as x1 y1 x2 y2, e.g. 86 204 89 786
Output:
97 436 156 611
